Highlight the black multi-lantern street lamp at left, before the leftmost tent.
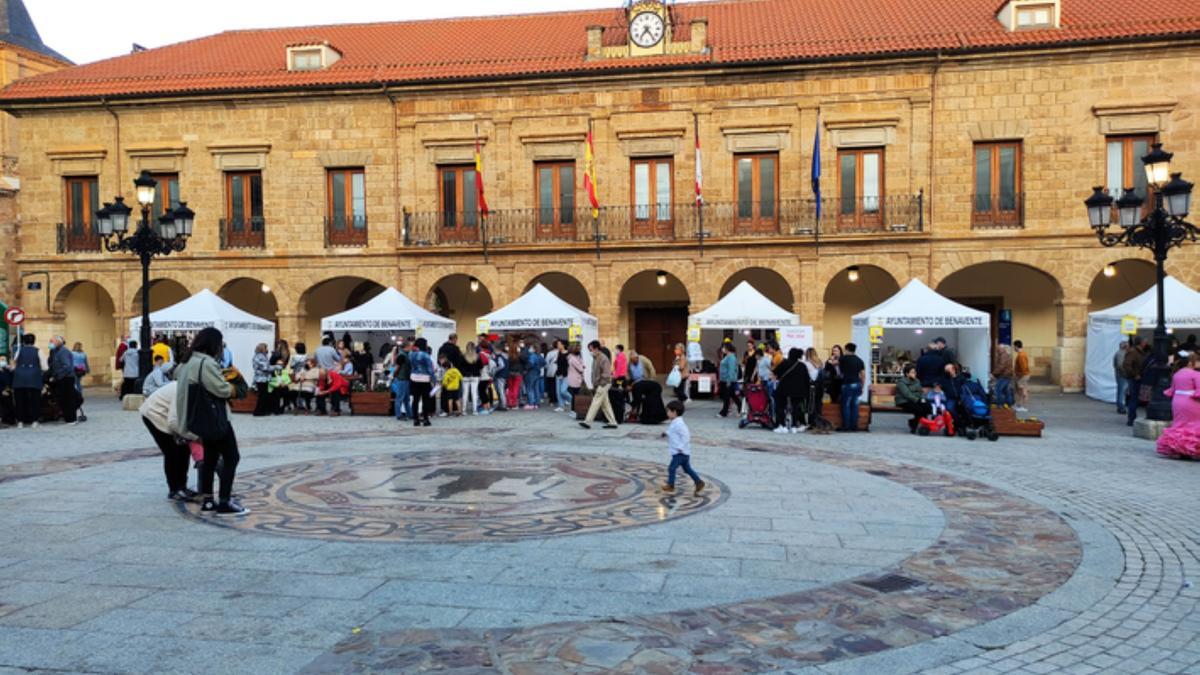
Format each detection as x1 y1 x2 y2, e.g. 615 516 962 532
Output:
96 171 196 384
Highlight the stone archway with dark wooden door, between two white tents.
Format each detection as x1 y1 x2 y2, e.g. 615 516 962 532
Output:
617 268 695 369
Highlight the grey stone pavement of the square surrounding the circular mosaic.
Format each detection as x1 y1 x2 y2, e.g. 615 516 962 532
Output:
0 395 1200 673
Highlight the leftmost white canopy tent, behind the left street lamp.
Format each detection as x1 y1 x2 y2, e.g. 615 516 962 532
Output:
130 288 275 374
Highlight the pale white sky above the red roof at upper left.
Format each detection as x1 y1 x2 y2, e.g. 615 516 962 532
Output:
25 0 623 64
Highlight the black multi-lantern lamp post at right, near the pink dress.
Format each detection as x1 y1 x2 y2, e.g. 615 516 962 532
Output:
1084 143 1200 420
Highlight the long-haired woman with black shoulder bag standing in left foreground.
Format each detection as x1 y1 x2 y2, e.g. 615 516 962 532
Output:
175 328 246 515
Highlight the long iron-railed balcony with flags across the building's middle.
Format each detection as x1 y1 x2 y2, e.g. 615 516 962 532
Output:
401 193 925 249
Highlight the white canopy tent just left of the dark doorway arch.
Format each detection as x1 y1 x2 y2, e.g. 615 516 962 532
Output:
478 283 600 378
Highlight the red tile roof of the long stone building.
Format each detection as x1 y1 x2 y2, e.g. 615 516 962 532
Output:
0 0 1200 104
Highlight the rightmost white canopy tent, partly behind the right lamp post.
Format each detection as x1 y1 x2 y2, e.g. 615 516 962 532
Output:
1084 276 1200 401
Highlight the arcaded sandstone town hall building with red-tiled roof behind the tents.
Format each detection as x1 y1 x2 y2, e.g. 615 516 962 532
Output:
0 0 1200 390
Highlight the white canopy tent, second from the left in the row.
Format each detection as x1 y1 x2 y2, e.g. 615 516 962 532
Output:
320 288 455 350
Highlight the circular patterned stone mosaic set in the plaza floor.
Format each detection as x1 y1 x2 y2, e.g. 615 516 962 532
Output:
180 450 728 543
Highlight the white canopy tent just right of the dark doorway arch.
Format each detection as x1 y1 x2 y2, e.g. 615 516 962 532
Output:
688 281 812 363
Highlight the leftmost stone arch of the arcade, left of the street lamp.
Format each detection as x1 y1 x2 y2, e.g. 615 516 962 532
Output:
51 279 118 382
